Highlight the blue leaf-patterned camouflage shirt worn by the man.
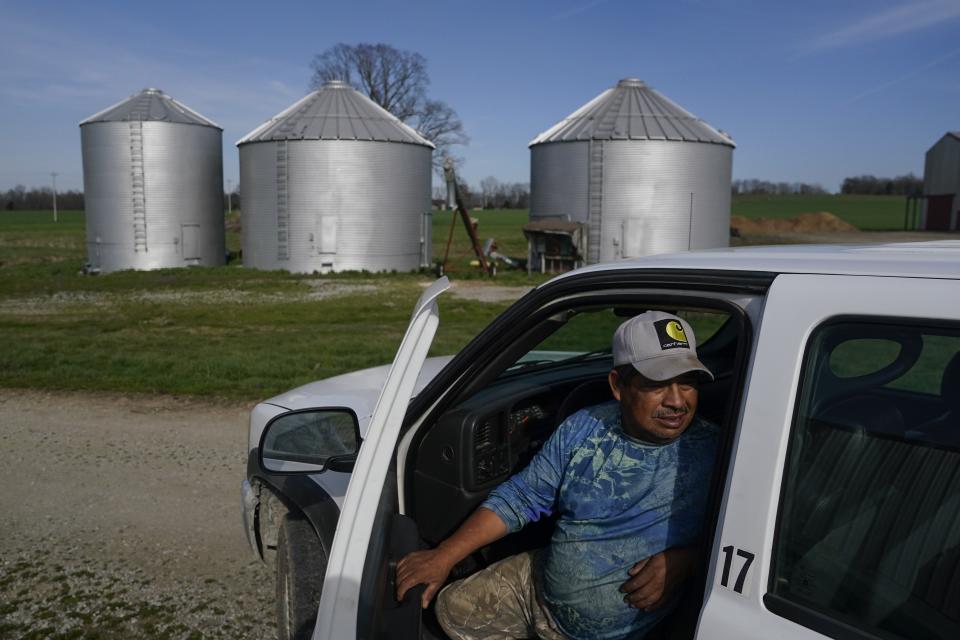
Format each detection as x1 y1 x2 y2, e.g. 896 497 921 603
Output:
483 402 719 640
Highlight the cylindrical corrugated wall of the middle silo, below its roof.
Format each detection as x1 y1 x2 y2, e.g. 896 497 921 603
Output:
240 140 432 273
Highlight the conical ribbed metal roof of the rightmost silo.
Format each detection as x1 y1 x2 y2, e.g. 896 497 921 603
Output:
530 78 736 147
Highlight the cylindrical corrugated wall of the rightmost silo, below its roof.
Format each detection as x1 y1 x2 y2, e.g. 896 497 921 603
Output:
530 140 733 263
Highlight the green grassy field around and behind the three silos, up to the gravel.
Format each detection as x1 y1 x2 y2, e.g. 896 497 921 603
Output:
0 196 944 401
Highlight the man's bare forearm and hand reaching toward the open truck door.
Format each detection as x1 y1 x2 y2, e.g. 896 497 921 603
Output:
397 507 507 609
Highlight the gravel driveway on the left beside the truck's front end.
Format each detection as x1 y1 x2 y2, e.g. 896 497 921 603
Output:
0 389 275 639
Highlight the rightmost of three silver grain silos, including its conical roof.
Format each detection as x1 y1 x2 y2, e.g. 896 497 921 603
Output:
525 78 735 269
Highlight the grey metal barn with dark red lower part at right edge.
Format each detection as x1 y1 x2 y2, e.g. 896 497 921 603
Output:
920 131 960 231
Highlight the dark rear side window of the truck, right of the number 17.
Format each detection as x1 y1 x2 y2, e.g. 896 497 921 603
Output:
764 320 960 638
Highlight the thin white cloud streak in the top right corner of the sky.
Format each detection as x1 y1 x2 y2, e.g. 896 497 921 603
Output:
806 0 960 53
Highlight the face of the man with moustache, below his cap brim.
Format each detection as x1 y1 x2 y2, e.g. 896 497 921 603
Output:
610 369 700 444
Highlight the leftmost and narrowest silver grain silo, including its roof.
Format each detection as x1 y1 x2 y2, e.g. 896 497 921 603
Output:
80 89 226 272
